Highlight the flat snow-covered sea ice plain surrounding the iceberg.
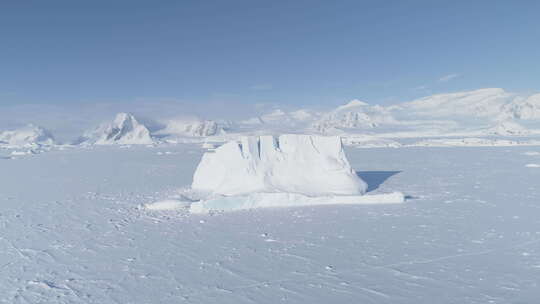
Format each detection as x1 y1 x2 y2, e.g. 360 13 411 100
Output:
0 145 540 304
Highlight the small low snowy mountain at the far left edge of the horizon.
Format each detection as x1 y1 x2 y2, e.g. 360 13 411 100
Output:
0 124 55 148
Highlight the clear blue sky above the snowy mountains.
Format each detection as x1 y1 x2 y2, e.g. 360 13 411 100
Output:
0 0 540 106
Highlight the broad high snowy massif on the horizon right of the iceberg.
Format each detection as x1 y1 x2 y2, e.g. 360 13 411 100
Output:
312 88 540 137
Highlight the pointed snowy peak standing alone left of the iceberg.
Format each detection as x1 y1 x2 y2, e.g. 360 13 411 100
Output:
82 113 154 145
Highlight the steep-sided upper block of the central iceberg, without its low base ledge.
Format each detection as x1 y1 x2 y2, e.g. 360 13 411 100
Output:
192 134 367 196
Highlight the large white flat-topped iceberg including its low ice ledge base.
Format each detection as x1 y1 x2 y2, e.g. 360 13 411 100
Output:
145 134 405 213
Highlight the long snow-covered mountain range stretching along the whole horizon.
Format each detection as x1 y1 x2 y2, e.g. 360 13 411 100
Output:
0 88 540 147
